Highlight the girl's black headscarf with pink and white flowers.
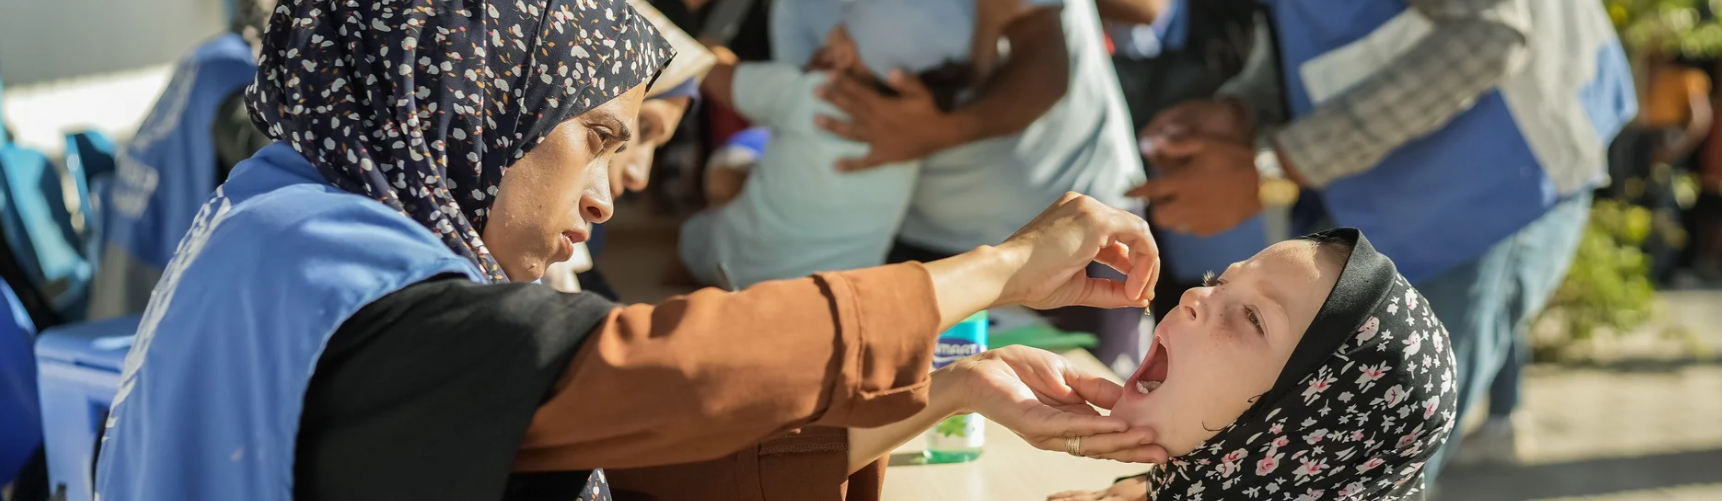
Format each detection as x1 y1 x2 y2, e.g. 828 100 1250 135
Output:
1150 229 1457 501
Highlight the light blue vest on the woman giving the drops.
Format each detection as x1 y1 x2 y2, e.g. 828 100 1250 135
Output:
96 143 482 501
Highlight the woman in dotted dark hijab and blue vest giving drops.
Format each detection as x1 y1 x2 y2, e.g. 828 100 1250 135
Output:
96 0 1155 501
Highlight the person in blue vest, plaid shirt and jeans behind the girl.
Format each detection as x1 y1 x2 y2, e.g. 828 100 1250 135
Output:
1133 0 1638 492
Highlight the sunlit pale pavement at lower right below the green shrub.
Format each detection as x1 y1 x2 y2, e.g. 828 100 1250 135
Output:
1438 291 1722 501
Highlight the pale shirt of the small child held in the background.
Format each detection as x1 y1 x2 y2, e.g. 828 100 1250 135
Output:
682 62 918 288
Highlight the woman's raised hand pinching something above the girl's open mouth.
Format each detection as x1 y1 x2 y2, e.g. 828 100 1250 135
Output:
999 193 1161 310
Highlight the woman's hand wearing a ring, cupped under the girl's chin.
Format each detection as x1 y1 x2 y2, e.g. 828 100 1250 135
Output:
942 346 1168 463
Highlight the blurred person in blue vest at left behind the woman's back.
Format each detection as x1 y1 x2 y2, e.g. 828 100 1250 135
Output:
88 0 276 320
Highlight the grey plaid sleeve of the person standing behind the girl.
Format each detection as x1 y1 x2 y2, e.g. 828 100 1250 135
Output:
1233 0 1531 188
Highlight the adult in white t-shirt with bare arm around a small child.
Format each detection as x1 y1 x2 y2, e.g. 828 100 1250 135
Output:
771 0 1154 373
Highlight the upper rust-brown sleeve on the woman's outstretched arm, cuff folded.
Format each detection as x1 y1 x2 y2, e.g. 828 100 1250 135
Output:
515 263 938 472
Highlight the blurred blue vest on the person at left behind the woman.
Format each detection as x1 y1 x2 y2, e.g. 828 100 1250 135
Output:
91 34 257 319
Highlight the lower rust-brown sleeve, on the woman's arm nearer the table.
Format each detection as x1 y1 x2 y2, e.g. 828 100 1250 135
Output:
604 427 885 501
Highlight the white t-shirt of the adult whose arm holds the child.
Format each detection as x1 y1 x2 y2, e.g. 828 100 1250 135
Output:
901 0 1147 253
